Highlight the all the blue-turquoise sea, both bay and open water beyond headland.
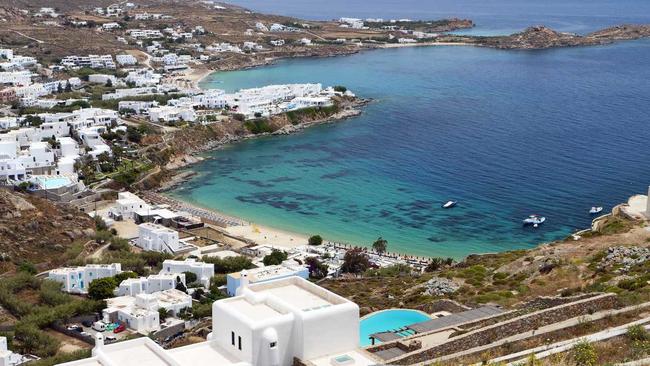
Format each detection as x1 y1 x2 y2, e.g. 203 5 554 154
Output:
170 0 650 259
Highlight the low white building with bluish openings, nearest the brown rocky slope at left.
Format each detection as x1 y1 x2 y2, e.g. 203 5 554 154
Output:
47 263 122 294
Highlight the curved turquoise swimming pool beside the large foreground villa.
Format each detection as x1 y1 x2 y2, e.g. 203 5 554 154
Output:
359 309 431 347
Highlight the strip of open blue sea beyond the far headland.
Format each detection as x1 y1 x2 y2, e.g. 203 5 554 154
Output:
224 0 650 35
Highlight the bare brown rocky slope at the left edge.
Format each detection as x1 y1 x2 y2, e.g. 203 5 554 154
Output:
0 189 95 272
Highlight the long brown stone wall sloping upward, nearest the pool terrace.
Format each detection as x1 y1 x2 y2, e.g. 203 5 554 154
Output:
389 294 619 365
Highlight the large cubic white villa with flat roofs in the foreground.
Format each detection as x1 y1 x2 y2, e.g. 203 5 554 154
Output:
63 273 374 366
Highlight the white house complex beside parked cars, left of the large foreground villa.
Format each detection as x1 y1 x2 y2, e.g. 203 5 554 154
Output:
102 289 192 334
